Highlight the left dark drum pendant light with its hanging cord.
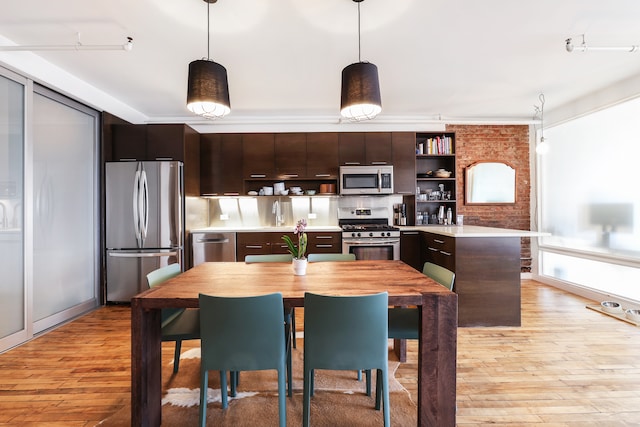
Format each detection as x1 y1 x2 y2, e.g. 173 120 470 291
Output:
187 0 231 119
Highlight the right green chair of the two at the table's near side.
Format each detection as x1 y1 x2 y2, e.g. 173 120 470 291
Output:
303 292 390 427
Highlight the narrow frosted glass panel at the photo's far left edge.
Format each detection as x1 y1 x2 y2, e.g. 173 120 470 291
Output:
0 76 25 342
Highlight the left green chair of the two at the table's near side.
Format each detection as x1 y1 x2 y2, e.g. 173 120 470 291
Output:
199 293 291 427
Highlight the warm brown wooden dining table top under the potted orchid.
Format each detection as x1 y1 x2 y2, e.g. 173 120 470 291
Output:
135 261 450 308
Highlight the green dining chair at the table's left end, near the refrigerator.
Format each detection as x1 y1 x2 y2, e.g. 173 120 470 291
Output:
147 264 200 374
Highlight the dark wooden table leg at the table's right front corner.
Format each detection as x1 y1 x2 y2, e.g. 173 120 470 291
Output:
418 293 458 427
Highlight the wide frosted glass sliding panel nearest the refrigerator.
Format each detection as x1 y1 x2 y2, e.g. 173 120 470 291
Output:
33 93 98 321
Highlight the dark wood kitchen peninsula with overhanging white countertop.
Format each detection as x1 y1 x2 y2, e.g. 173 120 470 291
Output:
403 225 547 326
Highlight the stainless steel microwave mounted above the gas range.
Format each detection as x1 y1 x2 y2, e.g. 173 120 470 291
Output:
340 166 393 195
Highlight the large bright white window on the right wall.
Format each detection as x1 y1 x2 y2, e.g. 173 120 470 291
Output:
538 99 640 301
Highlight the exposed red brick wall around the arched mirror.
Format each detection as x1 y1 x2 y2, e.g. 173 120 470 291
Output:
447 125 531 271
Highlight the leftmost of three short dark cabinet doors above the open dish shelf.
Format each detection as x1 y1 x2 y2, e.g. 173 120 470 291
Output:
242 133 275 179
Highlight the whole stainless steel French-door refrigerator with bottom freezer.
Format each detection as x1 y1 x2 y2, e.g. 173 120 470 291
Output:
105 161 184 302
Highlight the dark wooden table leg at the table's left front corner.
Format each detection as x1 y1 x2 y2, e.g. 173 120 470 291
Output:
131 298 162 426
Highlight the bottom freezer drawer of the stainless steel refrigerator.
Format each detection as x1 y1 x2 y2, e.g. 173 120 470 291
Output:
106 249 182 303
